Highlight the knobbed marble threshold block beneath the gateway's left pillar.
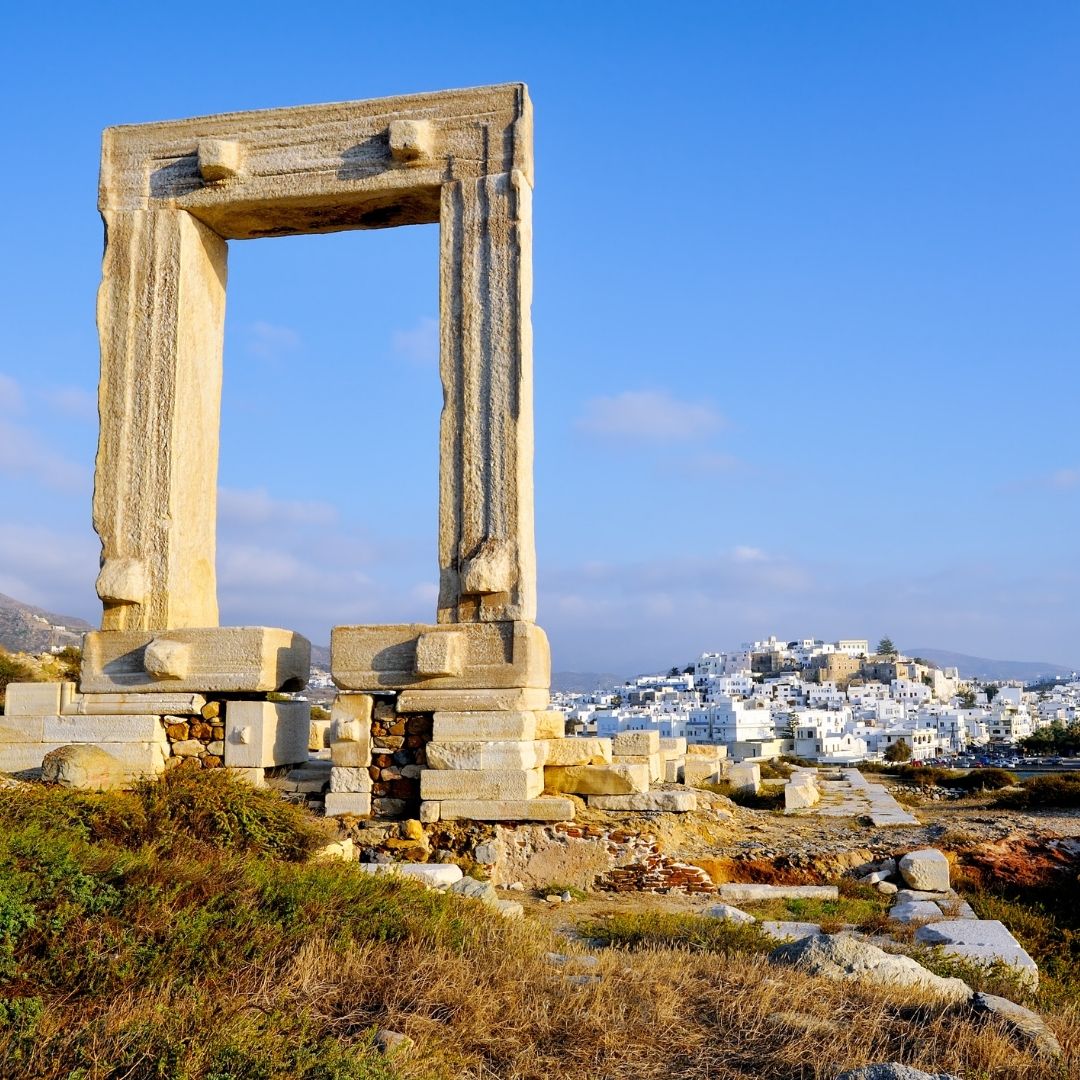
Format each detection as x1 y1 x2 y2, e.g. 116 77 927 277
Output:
79 626 311 691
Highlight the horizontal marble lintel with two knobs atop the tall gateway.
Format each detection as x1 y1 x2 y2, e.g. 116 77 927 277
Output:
99 83 532 240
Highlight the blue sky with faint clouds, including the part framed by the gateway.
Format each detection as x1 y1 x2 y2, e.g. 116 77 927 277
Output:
0 0 1080 673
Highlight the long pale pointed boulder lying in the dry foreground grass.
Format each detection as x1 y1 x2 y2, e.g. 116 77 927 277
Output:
769 934 972 1002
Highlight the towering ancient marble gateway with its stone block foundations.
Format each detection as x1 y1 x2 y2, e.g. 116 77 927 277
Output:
3 84 686 821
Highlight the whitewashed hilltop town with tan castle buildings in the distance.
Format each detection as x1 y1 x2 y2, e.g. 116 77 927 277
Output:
553 637 1080 765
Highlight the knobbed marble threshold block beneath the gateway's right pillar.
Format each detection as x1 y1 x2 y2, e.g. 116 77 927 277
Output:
330 621 551 690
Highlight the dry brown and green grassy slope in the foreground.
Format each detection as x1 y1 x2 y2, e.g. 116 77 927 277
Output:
0 772 1080 1080
